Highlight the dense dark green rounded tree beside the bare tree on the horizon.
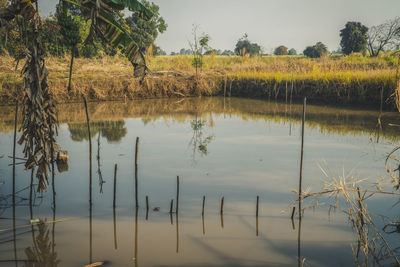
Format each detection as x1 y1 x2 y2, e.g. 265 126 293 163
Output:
340 21 368 55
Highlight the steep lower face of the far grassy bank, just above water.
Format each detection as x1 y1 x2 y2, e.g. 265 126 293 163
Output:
0 73 396 110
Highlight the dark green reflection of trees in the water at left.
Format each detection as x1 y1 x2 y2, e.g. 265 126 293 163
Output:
68 120 128 143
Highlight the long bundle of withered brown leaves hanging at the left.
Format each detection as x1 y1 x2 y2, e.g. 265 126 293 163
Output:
0 0 57 191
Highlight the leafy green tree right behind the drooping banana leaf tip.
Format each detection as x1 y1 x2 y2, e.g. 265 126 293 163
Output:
126 0 168 53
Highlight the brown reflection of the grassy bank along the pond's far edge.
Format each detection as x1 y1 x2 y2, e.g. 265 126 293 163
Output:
0 98 400 142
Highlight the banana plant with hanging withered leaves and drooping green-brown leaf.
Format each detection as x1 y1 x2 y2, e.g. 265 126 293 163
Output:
0 0 152 191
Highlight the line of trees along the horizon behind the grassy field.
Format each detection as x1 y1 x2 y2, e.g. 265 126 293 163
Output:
0 0 400 60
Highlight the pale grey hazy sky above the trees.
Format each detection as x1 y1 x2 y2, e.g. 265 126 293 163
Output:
39 0 400 53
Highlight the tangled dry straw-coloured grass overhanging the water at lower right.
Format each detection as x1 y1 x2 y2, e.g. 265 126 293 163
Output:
295 163 400 266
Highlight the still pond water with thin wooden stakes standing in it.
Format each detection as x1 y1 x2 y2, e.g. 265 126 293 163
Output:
0 98 400 266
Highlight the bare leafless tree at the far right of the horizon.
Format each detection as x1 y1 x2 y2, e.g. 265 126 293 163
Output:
368 17 400 57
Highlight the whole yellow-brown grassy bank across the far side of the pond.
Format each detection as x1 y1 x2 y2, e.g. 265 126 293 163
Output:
0 56 397 108
